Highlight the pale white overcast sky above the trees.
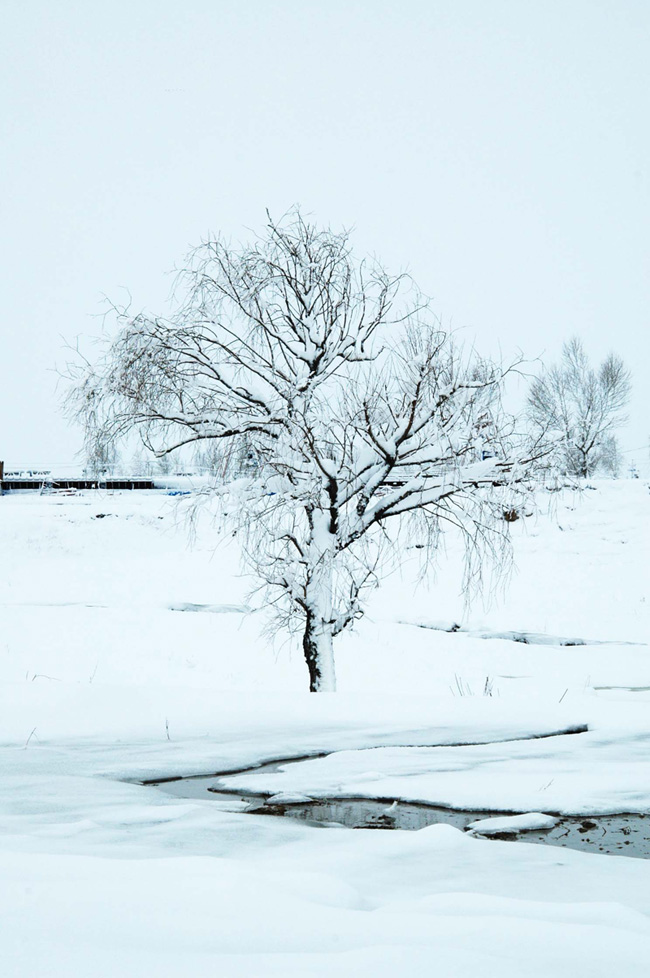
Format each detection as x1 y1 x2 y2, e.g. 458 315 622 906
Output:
0 0 650 466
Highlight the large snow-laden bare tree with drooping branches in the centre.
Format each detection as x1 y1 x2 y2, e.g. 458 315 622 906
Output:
69 211 527 691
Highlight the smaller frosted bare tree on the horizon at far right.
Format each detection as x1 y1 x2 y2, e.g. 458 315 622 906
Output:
528 337 630 478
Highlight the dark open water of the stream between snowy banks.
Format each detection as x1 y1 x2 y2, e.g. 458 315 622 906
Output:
147 761 650 859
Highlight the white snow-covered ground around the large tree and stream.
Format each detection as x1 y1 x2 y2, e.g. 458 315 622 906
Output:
0 480 650 978
